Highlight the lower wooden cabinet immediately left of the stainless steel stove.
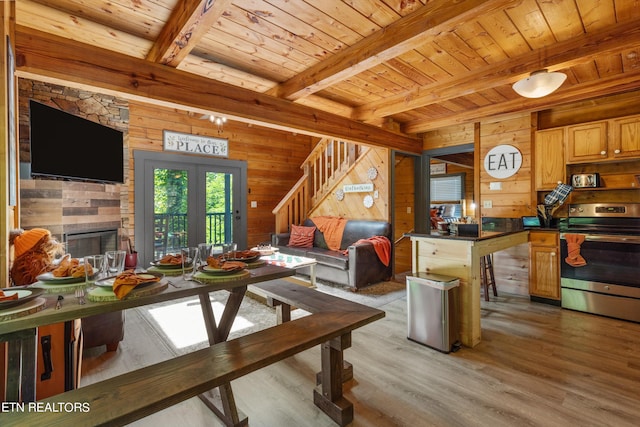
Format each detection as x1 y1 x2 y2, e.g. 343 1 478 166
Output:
529 231 560 301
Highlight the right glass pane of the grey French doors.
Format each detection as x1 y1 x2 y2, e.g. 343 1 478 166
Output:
205 172 233 246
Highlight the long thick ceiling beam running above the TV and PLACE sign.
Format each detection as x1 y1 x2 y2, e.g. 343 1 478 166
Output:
15 26 422 154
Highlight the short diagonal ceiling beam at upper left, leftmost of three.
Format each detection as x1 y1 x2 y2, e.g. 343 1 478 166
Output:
147 0 232 67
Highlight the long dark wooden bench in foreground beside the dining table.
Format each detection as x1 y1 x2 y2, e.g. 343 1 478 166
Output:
0 286 384 426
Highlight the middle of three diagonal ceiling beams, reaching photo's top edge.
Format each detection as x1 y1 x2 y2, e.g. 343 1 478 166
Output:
268 0 513 101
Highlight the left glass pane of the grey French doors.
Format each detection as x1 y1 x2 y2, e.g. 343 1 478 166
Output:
153 168 189 259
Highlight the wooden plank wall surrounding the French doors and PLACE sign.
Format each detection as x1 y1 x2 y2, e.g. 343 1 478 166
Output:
128 102 312 247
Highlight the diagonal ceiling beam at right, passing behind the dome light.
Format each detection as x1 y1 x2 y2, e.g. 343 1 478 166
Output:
351 21 640 122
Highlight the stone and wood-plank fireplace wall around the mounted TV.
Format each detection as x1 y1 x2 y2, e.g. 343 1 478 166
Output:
18 78 129 256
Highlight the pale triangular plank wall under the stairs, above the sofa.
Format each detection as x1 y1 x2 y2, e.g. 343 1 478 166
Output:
309 147 390 221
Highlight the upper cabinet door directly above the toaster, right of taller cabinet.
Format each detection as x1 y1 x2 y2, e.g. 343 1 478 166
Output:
566 121 610 163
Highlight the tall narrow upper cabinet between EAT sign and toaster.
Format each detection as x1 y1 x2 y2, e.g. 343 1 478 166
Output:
535 128 566 191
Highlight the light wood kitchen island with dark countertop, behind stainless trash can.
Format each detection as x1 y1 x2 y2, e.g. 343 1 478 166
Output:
407 230 529 347
